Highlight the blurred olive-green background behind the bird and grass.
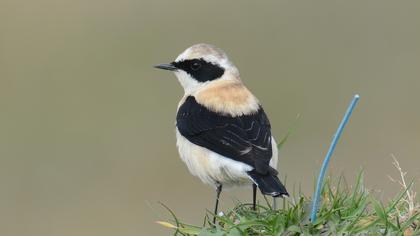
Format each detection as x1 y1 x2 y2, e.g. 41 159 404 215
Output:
0 0 420 236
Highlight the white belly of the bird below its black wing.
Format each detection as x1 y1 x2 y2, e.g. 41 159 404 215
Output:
176 130 277 187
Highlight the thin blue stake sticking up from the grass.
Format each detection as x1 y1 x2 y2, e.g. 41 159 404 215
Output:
311 94 360 223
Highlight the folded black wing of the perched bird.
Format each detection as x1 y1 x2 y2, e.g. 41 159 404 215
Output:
176 96 276 174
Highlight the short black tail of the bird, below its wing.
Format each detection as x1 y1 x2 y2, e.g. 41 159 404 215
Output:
248 170 289 197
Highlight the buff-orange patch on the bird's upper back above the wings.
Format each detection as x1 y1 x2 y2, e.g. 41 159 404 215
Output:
194 80 259 116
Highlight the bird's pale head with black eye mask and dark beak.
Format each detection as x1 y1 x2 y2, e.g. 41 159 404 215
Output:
155 43 240 94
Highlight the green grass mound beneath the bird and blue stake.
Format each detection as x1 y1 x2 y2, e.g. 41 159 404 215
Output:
157 171 420 236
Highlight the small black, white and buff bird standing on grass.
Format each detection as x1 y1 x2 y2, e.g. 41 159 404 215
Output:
154 43 289 223
